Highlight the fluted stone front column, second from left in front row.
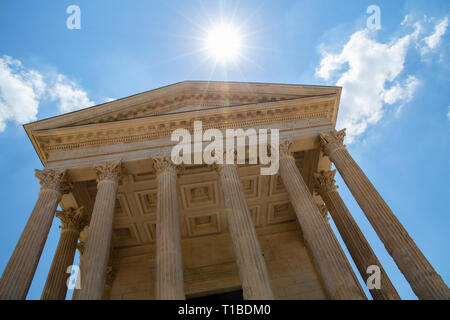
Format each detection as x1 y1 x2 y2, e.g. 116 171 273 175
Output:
77 160 122 300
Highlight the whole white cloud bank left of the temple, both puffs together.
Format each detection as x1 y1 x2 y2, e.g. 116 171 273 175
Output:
0 56 94 132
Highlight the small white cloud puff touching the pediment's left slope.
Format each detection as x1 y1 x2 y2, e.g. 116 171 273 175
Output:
48 74 95 113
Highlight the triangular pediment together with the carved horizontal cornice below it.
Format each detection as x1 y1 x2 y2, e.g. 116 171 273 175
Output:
24 81 341 163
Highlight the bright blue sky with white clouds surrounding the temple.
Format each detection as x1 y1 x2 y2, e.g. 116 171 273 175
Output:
0 0 450 299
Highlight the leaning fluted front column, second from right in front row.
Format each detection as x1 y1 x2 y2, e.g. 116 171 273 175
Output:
280 140 366 300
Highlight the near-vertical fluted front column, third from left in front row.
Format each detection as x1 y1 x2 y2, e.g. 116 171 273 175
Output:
153 157 185 300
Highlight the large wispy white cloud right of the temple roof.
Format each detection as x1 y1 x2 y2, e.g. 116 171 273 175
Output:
316 15 448 143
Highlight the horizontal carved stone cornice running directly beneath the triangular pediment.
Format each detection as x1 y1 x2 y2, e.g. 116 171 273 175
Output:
32 94 337 163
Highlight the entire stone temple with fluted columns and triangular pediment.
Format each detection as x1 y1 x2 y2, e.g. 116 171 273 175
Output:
0 81 450 300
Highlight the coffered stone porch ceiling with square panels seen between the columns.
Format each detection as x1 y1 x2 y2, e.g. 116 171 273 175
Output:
74 150 319 248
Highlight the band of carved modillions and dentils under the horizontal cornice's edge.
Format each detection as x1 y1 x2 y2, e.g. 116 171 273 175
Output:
37 100 333 158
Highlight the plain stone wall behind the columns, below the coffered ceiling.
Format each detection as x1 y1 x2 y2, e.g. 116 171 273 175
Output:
105 223 326 299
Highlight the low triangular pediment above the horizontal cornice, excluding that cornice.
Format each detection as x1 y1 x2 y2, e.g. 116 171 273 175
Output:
25 81 340 131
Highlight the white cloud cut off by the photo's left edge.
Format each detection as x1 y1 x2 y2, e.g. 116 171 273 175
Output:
0 56 45 132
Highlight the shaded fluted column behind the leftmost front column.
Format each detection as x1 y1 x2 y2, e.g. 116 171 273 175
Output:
41 207 87 300
